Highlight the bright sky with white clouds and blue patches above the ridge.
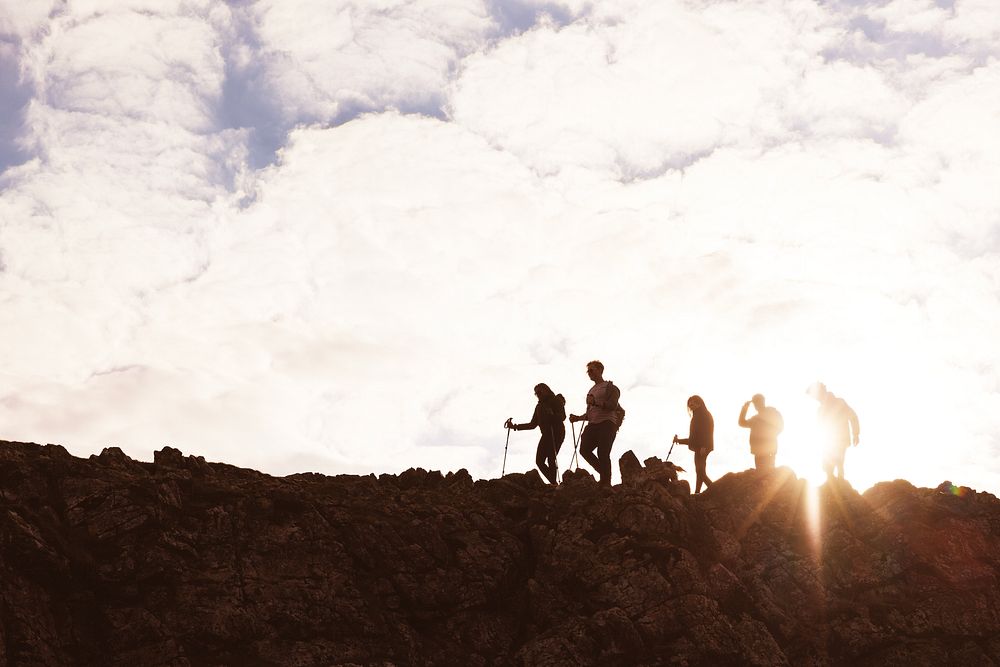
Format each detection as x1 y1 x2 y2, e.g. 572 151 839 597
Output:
0 0 1000 493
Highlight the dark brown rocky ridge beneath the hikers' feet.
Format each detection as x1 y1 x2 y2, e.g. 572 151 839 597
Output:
0 443 1000 666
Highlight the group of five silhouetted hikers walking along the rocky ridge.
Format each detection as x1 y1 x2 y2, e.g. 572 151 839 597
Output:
504 360 861 493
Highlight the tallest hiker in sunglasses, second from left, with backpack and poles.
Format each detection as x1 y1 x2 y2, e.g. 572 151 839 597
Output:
569 361 625 486
